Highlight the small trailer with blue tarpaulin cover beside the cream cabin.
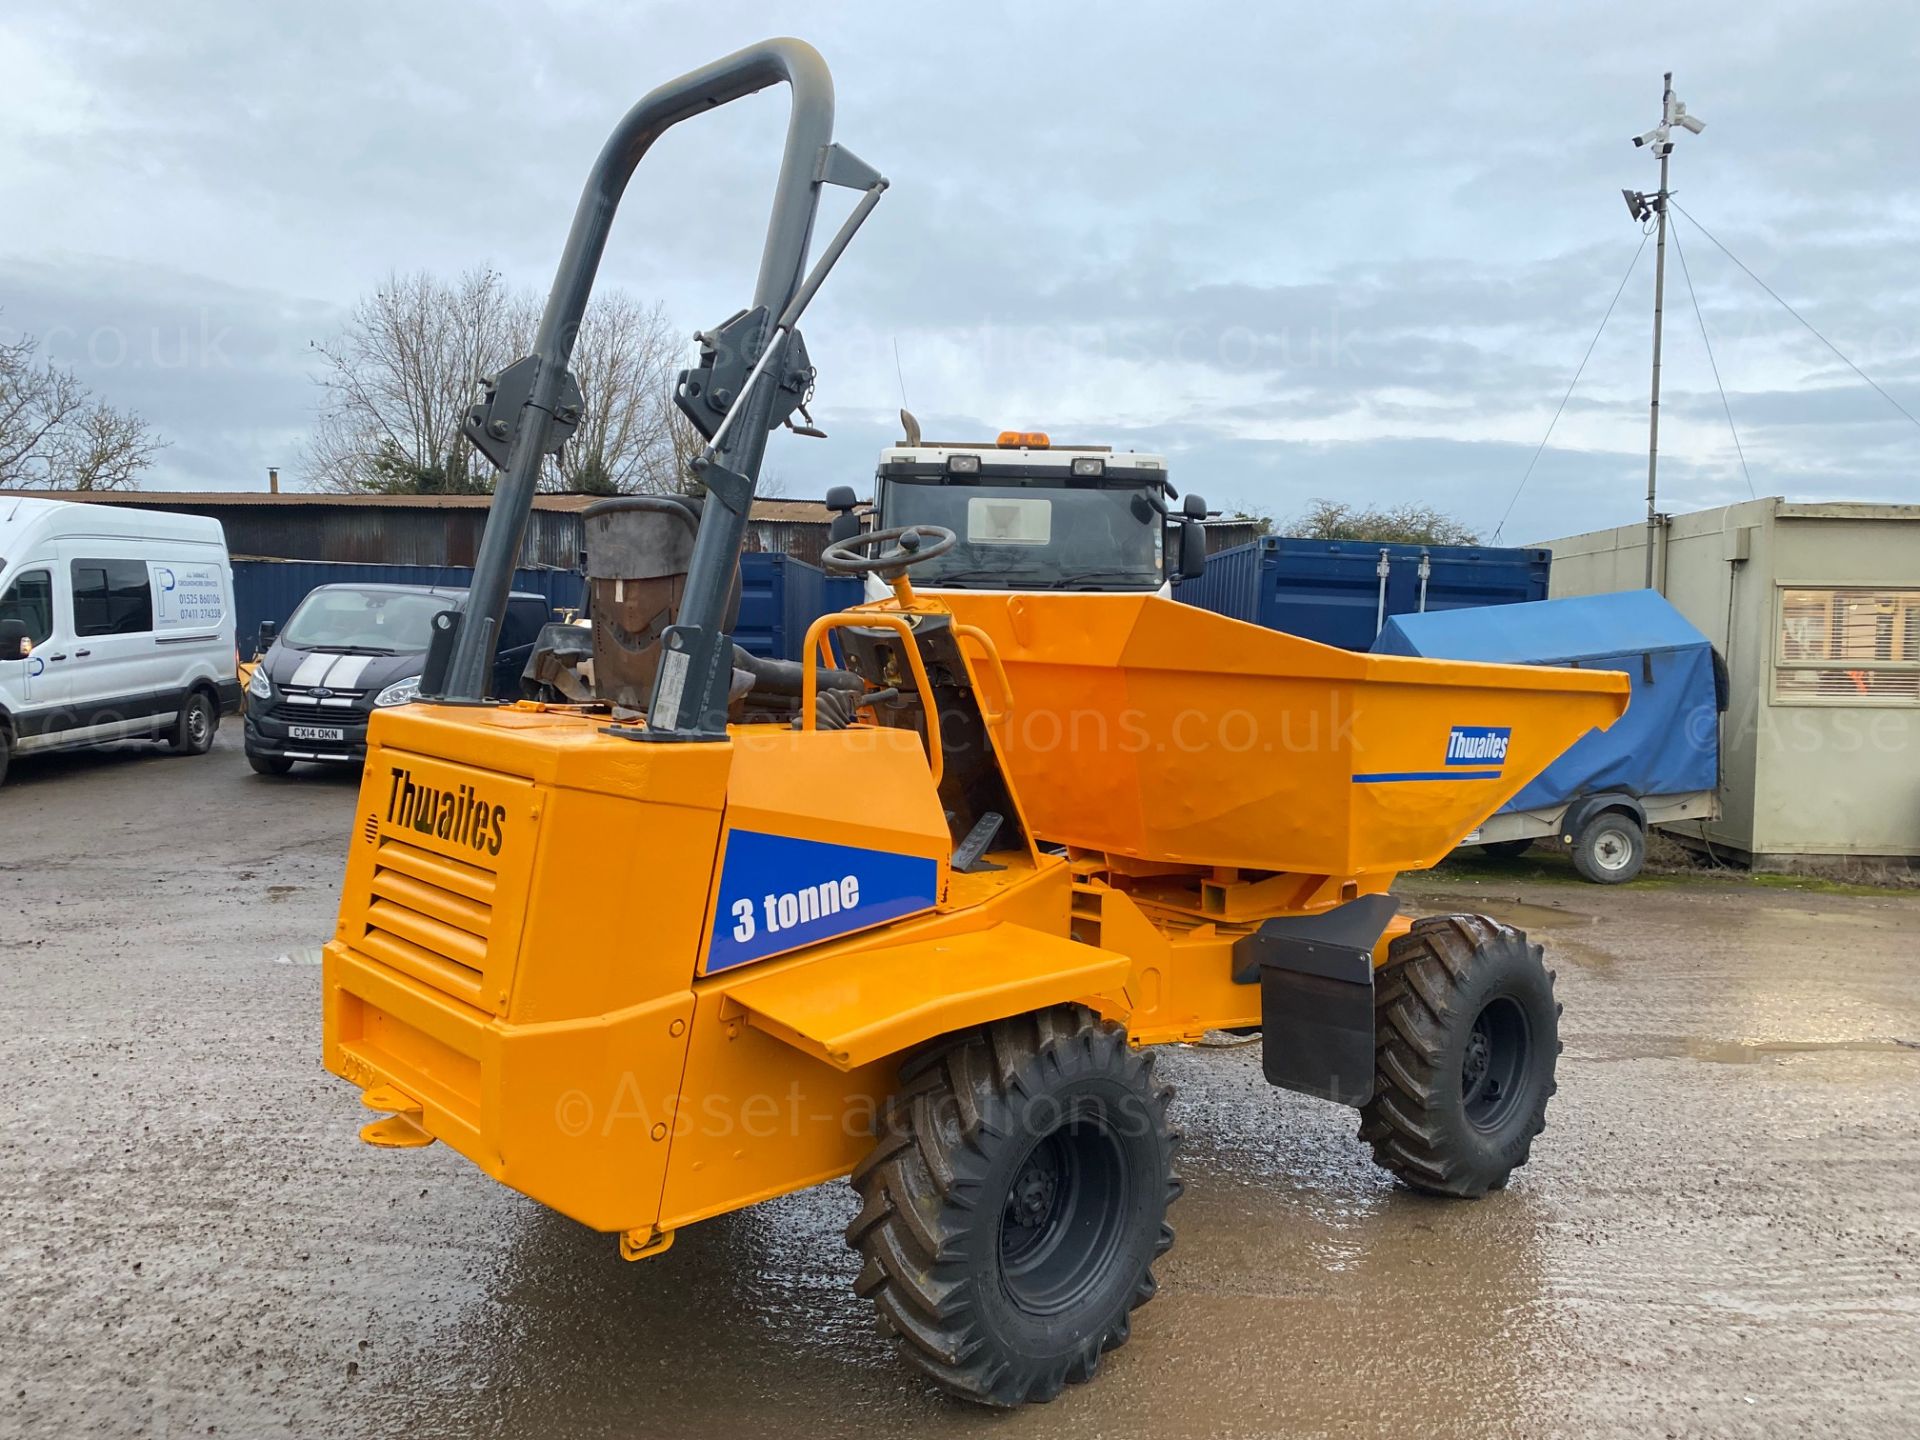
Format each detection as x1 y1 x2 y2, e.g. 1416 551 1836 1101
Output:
1373 589 1726 885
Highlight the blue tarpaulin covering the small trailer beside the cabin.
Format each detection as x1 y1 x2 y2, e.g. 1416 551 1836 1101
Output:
1373 589 1720 810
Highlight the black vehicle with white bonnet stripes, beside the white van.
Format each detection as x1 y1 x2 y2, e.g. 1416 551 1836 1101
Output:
246 586 551 776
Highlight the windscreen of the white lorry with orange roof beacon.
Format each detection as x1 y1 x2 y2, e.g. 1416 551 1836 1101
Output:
881 476 1165 589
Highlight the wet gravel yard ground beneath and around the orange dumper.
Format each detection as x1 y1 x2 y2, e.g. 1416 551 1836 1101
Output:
0 737 1920 1440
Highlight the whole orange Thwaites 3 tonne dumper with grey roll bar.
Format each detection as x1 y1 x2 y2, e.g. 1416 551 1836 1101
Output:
324 40 1624 1405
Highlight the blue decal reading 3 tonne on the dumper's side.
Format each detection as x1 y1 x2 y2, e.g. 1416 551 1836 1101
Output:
707 829 939 975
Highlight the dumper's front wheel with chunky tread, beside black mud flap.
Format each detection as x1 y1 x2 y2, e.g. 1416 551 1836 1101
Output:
1359 916 1561 1198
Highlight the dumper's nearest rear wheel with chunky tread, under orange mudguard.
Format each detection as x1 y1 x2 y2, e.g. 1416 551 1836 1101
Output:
847 1006 1181 1405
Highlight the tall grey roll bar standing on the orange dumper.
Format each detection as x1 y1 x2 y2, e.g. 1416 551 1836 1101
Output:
442 40 887 739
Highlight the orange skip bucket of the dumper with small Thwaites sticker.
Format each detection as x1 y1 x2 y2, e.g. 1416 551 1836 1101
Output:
941 591 1628 876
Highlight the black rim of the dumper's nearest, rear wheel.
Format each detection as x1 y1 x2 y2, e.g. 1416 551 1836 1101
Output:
1000 1117 1129 1315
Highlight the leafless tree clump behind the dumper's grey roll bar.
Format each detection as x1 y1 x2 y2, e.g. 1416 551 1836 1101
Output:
307 271 702 495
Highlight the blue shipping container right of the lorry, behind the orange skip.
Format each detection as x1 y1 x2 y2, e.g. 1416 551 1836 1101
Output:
1173 536 1553 651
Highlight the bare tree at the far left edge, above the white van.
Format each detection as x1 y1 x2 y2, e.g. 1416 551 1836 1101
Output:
0 322 165 490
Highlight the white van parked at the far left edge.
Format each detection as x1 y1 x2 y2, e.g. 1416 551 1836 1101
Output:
0 492 240 780
